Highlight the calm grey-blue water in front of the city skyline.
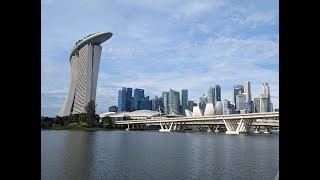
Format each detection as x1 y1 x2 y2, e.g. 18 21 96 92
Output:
41 130 279 180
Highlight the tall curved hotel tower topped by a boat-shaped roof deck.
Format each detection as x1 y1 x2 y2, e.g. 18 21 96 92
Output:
59 32 112 117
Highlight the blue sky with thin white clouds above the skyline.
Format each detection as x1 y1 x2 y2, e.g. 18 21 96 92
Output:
41 0 279 116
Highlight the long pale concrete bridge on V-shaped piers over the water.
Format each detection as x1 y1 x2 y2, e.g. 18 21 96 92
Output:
113 112 279 134
